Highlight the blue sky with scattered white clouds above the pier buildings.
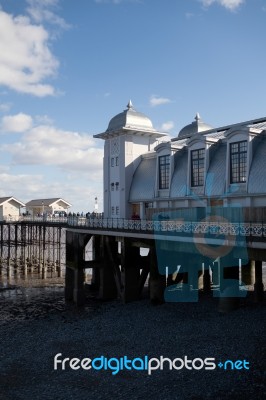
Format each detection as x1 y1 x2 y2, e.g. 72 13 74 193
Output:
0 0 266 212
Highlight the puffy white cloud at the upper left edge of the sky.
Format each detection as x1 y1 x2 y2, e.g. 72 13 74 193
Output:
0 9 59 97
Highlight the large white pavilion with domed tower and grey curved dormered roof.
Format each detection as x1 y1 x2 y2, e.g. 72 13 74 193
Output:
94 102 266 218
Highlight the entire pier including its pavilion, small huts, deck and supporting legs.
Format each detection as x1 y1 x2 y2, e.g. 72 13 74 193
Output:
0 101 266 307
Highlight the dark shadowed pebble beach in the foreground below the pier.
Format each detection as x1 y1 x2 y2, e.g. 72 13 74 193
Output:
0 286 266 400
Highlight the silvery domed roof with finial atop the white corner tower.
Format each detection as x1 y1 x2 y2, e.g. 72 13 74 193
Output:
106 100 154 132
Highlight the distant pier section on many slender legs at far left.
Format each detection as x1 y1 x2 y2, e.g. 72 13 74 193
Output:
0 219 65 279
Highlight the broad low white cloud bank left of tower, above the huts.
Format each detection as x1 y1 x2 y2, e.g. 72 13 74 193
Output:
0 113 103 212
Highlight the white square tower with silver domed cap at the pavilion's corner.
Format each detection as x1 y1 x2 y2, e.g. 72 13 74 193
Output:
94 100 166 218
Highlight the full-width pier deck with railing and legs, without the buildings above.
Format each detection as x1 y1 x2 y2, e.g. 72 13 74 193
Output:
0 208 266 305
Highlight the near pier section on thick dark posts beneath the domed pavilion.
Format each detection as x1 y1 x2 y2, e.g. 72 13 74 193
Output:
63 208 266 304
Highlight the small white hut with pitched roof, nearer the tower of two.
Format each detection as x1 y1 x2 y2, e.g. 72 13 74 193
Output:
26 197 71 216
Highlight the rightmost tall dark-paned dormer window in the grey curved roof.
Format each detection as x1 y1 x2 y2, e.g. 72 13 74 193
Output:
230 140 247 183
